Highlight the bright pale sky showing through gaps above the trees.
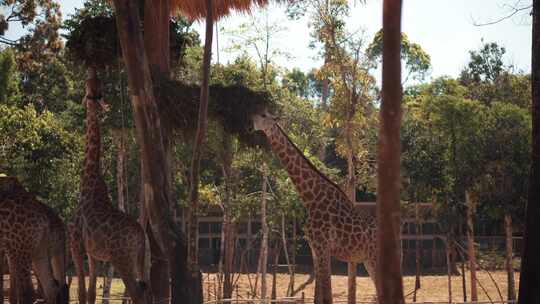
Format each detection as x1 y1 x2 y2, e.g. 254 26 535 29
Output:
3 0 531 77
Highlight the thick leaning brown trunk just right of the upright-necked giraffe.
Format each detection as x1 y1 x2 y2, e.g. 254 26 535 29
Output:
114 0 175 301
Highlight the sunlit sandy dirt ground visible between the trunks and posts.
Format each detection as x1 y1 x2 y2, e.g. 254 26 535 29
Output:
5 271 519 303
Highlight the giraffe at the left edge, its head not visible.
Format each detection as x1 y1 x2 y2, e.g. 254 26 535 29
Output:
0 176 69 304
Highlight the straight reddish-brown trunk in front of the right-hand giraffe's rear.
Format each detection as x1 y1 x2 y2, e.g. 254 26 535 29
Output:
375 0 405 303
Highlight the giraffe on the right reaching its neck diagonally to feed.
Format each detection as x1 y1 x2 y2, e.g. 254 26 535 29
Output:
252 113 377 304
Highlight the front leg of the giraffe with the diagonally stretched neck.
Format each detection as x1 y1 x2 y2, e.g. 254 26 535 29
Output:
313 246 332 304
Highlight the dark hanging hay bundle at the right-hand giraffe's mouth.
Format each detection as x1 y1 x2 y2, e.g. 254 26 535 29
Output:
155 75 275 147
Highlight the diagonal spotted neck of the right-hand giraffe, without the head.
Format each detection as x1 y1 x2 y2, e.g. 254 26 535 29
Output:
264 123 352 206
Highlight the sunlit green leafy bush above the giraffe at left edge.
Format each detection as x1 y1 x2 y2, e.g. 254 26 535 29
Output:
0 105 81 215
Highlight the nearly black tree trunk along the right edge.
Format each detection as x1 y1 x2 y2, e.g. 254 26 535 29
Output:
518 0 540 304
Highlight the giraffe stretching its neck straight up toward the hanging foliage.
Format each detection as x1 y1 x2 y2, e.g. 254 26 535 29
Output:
68 67 150 304
